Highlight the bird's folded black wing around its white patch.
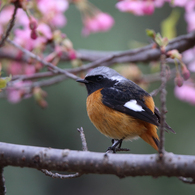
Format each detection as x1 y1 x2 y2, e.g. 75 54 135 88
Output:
101 87 159 126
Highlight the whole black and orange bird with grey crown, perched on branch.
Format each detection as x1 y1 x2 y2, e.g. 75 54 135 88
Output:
77 66 175 153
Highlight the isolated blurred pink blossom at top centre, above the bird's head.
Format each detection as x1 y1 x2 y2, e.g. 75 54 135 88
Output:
82 12 114 36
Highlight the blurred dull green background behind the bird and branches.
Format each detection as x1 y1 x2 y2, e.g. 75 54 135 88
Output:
0 0 195 195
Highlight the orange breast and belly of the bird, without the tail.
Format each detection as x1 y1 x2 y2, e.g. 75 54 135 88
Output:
87 90 147 139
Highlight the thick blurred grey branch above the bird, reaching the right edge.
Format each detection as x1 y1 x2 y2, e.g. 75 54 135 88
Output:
73 32 195 63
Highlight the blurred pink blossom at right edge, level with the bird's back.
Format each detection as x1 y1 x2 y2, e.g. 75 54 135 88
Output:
174 81 195 105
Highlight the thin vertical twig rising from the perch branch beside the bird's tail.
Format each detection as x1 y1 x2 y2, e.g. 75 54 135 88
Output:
159 53 167 159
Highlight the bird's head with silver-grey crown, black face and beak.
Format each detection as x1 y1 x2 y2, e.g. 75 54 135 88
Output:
77 66 125 95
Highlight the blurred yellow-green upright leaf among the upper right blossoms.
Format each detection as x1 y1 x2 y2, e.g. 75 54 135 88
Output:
161 9 180 39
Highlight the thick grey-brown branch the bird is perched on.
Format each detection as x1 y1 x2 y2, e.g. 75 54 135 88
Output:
0 142 195 178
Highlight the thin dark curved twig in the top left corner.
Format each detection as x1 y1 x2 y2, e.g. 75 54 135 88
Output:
0 1 19 47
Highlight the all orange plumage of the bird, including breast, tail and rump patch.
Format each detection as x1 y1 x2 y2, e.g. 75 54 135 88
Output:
87 89 159 150
